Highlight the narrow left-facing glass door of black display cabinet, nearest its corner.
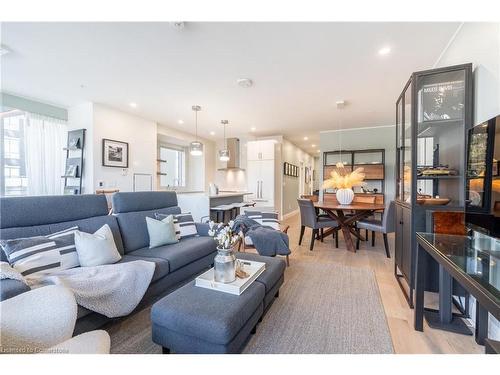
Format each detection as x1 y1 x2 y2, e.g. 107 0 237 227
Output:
402 82 413 203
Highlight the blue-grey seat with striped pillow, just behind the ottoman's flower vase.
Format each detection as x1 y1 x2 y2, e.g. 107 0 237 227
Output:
232 215 291 257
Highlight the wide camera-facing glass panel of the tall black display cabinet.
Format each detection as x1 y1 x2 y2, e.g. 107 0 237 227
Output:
414 69 466 207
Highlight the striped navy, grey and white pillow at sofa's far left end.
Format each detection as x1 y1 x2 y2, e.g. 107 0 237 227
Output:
2 226 80 277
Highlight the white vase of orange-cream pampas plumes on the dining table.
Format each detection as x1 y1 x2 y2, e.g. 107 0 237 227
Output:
323 162 365 205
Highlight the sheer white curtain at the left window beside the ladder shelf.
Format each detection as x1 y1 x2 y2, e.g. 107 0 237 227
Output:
24 113 67 195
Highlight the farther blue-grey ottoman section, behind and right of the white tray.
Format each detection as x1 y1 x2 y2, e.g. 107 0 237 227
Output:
236 253 286 311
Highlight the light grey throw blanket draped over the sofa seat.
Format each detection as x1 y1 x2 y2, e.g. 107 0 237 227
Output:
29 260 155 318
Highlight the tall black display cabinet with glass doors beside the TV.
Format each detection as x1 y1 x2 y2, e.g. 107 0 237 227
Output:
394 64 473 308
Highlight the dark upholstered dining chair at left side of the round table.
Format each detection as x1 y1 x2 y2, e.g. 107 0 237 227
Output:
297 199 339 251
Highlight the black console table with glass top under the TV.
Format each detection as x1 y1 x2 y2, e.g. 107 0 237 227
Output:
414 233 500 352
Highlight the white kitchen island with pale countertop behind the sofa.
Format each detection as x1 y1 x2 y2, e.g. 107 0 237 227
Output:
177 190 252 222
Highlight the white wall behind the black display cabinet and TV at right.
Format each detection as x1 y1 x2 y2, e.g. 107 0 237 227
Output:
436 23 500 340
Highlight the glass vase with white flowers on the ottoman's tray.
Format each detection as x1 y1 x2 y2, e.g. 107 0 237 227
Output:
208 221 240 283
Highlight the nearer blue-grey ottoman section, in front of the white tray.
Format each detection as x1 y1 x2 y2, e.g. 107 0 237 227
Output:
151 281 266 354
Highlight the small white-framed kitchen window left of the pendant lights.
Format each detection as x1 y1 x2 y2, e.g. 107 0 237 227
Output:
159 146 186 188
